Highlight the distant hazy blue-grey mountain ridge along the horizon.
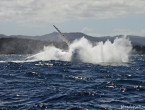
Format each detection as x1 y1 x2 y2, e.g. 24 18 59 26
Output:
0 32 145 46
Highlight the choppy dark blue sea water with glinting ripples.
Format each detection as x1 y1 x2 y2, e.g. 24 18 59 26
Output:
0 55 145 110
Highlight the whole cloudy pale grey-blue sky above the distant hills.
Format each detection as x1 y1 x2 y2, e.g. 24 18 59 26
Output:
0 0 145 37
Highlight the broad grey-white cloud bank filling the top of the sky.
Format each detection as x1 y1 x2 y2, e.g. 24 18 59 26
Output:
0 0 145 25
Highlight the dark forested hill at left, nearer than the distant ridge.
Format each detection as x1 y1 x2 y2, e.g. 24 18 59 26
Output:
0 38 67 54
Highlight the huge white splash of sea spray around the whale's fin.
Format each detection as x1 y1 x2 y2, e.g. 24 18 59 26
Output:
27 36 132 64
